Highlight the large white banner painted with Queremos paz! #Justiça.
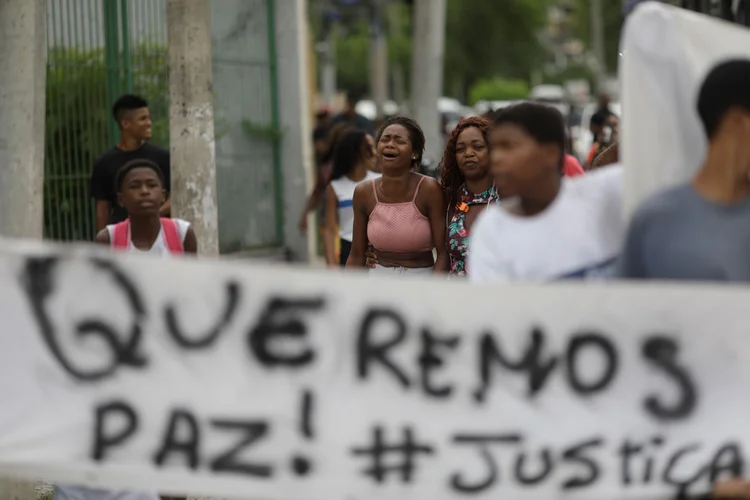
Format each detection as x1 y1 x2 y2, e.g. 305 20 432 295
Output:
0 242 750 500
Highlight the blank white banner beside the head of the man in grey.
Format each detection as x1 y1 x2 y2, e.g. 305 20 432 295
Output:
620 2 750 215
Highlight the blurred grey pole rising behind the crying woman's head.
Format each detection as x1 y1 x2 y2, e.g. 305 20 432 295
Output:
410 0 446 161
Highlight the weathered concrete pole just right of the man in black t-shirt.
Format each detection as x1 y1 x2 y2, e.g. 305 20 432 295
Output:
167 0 219 256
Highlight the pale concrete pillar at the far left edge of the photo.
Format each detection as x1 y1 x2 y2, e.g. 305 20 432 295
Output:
0 0 47 242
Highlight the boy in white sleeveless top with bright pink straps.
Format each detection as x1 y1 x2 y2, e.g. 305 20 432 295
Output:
63 159 198 500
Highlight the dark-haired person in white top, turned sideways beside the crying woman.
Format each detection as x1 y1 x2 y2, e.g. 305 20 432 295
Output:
323 129 380 267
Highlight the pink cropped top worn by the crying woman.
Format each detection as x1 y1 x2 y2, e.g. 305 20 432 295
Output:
367 177 434 253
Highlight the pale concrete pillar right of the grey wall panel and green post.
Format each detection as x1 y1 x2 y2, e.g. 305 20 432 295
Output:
272 0 315 261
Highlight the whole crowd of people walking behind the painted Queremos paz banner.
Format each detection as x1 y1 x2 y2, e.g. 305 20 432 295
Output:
67 52 750 500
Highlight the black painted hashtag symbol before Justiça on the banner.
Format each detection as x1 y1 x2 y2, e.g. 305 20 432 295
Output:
352 426 434 483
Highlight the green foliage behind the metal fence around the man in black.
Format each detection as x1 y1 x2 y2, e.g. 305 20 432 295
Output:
44 44 169 240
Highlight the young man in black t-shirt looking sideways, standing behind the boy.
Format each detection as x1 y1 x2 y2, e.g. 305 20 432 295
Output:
91 94 171 232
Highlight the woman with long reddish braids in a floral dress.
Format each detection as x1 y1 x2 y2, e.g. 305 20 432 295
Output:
367 117 498 278
